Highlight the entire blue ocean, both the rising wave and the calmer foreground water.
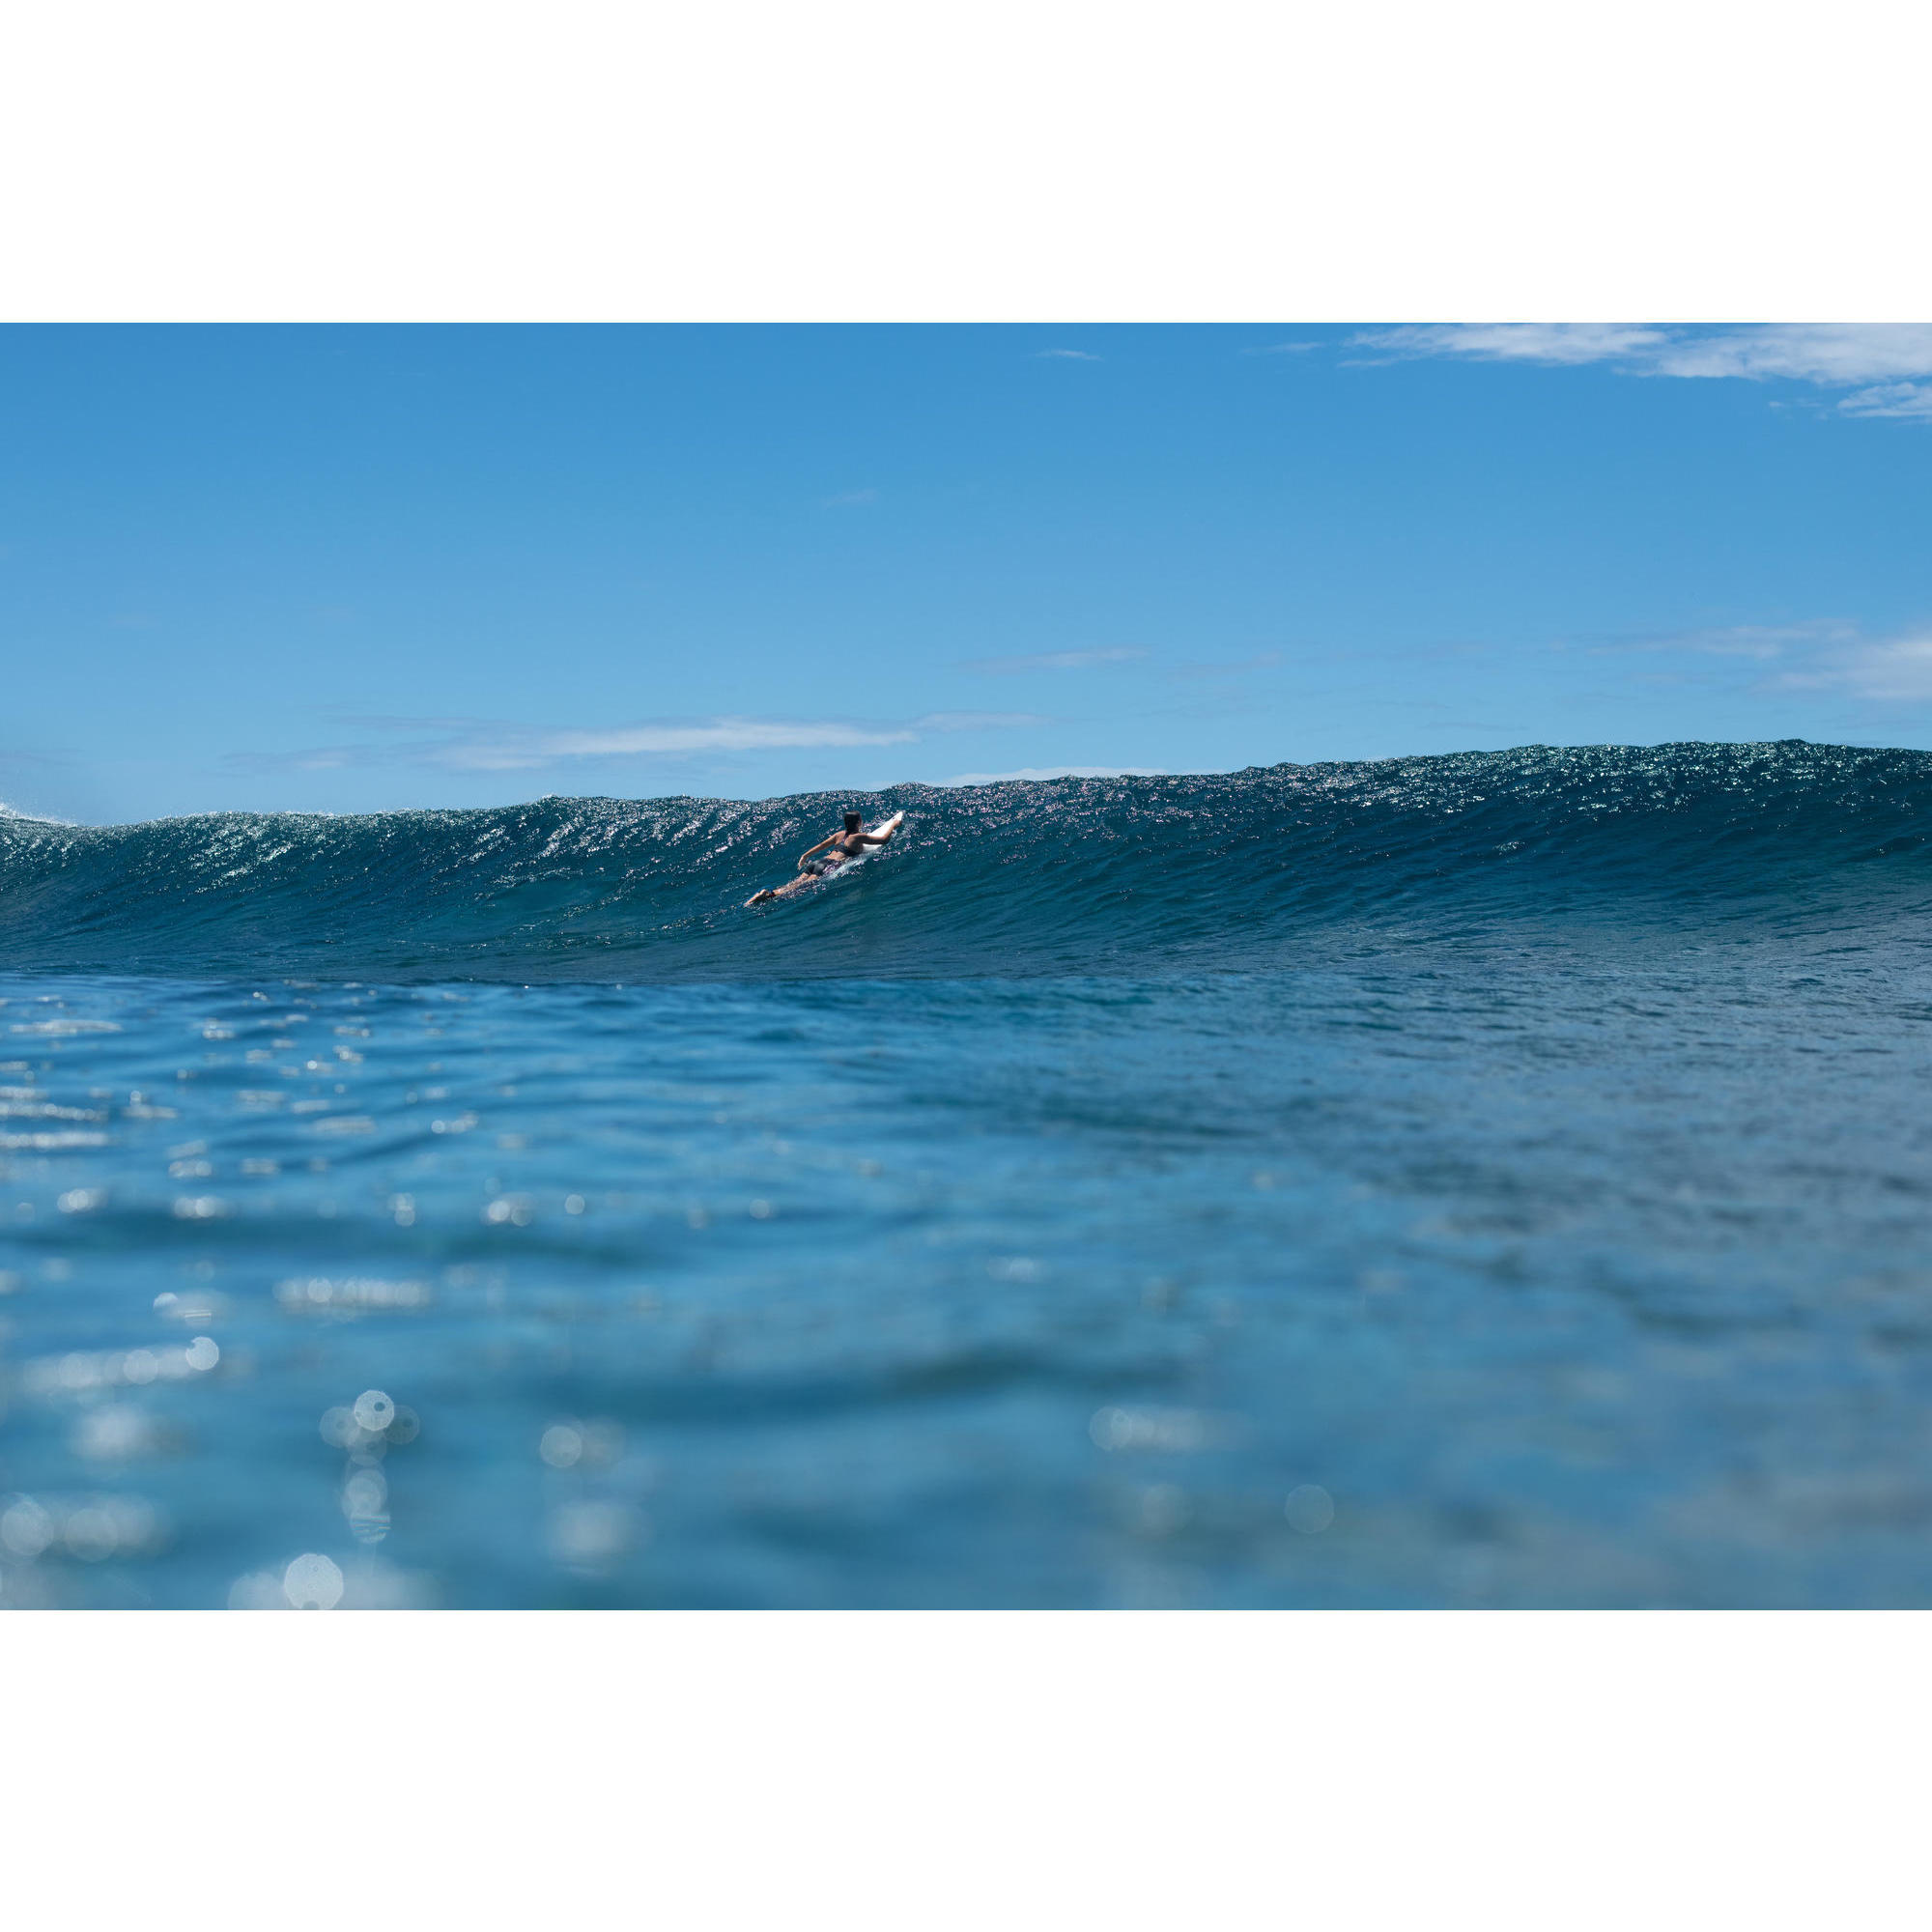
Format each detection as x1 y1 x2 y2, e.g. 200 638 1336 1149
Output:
0 744 1932 1607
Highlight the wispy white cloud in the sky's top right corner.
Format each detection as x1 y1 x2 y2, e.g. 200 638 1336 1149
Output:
1350 323 1932 421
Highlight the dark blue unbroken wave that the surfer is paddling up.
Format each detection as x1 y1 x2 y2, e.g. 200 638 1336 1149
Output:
0 740 1932 981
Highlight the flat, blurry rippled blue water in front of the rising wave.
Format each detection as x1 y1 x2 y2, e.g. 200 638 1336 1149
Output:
0 960 1932 1604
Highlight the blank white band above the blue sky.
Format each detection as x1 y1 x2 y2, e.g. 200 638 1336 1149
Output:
0 0 1932 323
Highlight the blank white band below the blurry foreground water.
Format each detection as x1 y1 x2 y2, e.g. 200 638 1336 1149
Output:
4 1613 1932 1932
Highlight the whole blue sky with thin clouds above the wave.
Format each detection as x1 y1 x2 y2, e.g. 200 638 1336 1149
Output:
0 325 1932 821
